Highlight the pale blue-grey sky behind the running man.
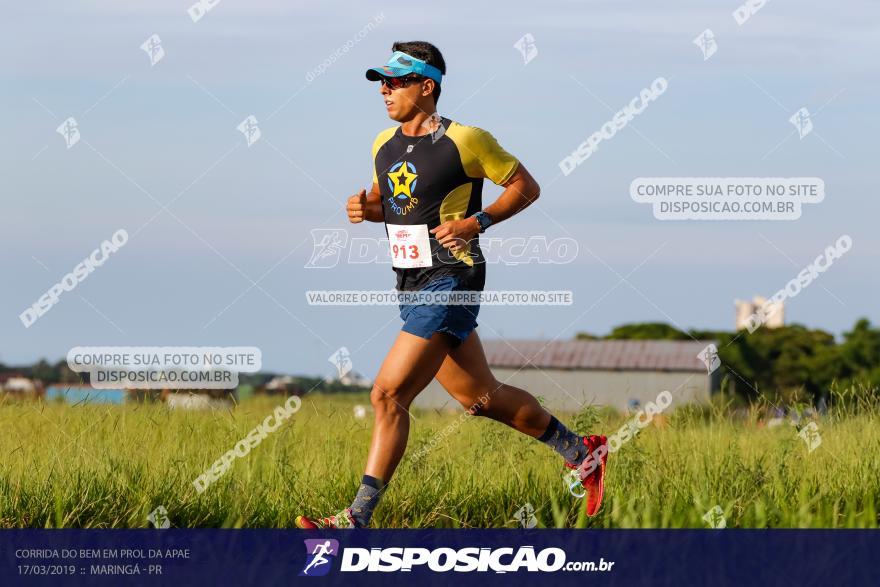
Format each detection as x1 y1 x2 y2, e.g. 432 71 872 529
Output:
0 0 880 376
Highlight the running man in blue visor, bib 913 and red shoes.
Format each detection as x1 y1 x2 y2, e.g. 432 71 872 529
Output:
296 41 607 528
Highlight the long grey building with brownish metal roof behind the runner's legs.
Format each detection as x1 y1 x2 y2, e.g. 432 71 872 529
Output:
414 340 718 412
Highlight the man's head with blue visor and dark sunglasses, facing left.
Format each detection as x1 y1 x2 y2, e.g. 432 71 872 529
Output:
367 41 446 122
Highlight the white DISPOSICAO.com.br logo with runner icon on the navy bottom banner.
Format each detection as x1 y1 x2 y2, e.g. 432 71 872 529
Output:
300 539 614 576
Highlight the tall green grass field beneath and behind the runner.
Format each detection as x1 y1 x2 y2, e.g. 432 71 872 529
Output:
0 395 880 528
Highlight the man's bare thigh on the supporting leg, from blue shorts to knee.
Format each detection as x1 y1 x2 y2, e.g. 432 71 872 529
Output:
374 331 451 405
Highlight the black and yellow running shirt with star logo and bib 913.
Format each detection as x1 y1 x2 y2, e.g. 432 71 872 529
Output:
373 118 519 291
